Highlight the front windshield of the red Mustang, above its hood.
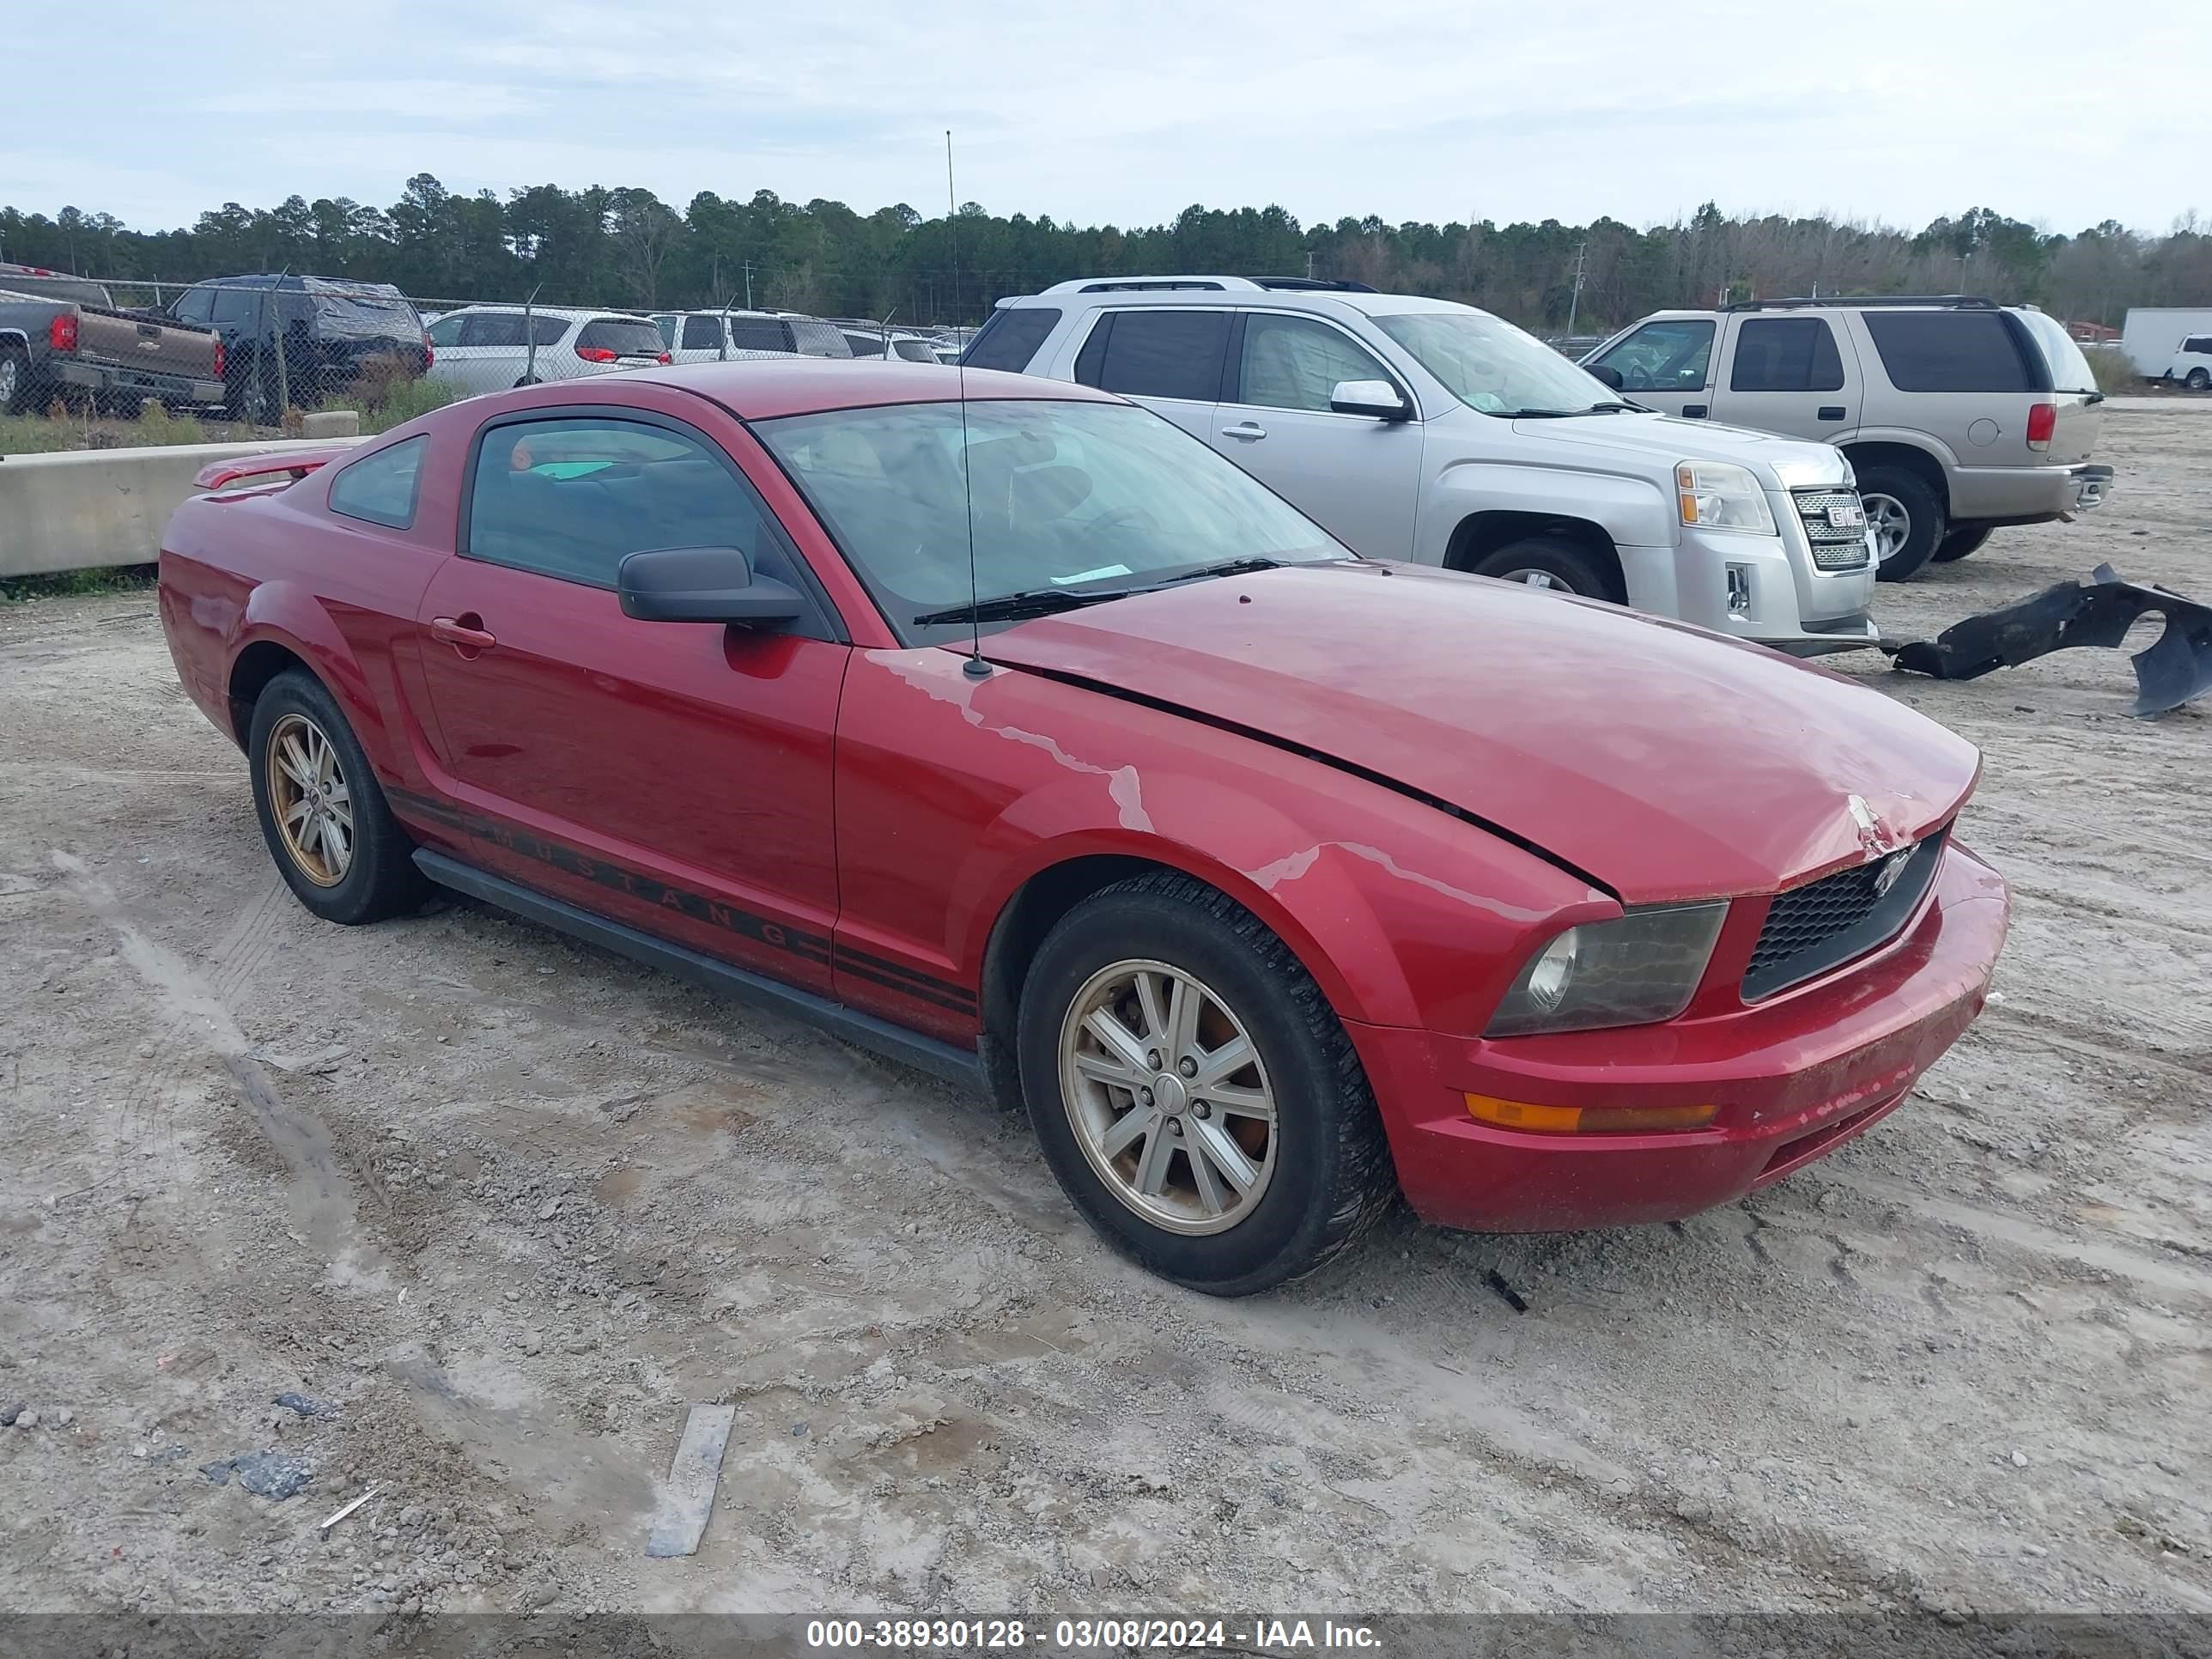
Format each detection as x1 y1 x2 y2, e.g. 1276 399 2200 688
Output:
752 400 1352 644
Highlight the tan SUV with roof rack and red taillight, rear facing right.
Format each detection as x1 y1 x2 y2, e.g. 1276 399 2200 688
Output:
1583 296 2112 581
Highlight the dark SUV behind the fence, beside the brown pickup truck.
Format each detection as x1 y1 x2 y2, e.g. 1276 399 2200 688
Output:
168 274 431 425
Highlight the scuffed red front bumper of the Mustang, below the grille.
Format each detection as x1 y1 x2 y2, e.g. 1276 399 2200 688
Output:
1345 845 2006 1232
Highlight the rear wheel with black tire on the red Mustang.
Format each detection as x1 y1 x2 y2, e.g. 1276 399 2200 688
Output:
246 668 429 927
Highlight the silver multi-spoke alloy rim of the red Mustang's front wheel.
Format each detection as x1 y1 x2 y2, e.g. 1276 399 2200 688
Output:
1060 960 1279 1234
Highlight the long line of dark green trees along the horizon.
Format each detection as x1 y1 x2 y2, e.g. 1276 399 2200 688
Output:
0 173 2212 334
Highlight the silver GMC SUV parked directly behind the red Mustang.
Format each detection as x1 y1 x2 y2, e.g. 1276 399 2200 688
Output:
963 276 1875 653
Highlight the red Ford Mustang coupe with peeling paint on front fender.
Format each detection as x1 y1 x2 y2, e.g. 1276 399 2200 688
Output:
161 362 2006 1294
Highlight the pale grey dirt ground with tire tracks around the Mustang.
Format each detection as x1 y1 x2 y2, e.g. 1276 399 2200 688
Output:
0 403 2212 1613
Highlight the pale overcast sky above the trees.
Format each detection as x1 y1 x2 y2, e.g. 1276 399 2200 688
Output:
0 0 2212 232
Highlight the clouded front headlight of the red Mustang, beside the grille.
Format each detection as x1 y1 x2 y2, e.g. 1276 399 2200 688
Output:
1484 900 1728 1037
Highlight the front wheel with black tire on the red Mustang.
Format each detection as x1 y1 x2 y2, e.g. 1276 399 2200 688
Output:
1015 874 1398 1297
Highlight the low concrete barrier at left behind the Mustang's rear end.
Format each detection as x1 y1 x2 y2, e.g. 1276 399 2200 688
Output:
0 438 356 575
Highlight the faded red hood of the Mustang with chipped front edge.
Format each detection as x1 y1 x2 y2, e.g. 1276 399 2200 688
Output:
987 562 1980 905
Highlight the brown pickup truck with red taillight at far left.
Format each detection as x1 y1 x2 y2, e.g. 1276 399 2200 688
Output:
0 265 223 414
